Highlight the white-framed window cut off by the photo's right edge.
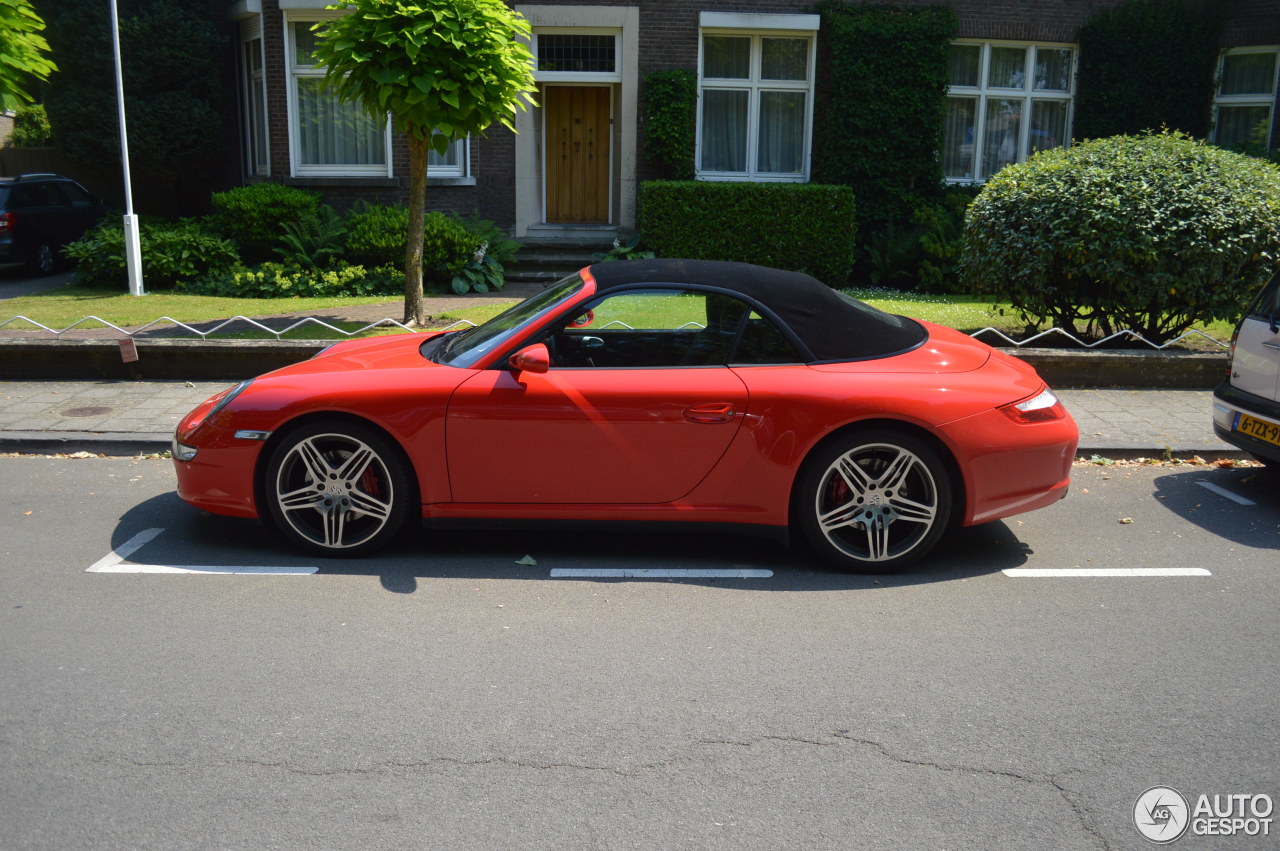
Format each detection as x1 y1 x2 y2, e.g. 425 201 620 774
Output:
1213 47 1280 148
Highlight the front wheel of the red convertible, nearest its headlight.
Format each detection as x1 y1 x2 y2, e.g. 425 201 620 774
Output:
261 421 417 558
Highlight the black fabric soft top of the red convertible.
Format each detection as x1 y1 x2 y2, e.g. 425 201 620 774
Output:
590 260 928 361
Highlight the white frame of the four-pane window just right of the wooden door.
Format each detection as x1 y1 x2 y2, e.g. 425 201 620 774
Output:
694 24 818 183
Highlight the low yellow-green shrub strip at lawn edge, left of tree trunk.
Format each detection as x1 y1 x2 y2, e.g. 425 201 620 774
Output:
179 262 404 298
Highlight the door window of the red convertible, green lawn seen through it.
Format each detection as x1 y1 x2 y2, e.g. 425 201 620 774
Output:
547 289 749 369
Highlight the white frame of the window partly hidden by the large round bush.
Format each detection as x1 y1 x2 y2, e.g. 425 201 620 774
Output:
943 38 1080 183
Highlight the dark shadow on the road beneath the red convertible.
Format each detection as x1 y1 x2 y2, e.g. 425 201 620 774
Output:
111 494 1029 594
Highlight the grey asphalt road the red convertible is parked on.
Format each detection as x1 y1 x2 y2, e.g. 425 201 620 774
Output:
0 458 1280 850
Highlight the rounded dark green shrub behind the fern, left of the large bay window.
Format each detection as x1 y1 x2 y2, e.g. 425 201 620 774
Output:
209 183 320 264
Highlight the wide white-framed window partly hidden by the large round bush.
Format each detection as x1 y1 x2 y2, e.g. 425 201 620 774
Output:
942 41 1075 182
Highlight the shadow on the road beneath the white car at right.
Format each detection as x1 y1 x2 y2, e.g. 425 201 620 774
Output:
1152 467 1280 549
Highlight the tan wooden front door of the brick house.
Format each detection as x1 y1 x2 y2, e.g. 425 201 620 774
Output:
543 86 611 223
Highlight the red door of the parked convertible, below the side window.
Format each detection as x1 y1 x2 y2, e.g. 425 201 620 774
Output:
445 366 746 504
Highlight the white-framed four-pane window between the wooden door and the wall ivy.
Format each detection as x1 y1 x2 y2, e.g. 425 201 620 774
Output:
698 27 815 182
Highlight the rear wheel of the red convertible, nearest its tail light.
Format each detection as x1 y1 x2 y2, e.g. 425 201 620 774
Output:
792 429 951 575
